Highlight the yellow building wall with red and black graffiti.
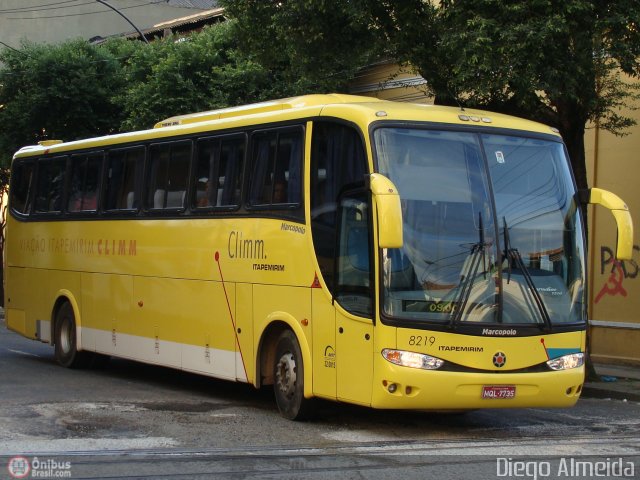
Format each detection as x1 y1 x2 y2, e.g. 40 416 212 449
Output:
585 95 640 366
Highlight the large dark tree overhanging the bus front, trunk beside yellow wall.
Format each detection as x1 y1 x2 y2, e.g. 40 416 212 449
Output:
221 0 640 189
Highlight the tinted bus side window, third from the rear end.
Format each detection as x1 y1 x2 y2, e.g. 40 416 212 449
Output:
67 153 102 212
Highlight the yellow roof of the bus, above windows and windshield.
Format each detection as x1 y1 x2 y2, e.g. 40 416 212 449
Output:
14 93 559 158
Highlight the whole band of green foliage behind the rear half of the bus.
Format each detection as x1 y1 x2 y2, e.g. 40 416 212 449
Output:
0 22 308 169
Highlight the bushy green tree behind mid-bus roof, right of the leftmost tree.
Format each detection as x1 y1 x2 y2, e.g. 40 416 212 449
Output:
117 22 291 130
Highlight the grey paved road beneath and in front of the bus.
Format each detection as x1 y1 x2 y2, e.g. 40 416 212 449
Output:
0 324 640 480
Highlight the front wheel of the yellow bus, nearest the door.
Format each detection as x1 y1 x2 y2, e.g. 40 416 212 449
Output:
273 330 310 420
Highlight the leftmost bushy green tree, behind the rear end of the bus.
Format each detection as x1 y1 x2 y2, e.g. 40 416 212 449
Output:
0 40 124 166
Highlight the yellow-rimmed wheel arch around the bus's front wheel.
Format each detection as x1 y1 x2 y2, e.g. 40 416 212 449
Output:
255 312 313 398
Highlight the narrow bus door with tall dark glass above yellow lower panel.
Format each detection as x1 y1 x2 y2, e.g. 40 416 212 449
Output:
334 189 374 405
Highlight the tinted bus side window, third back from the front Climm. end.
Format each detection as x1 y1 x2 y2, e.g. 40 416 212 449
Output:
146 142 191 209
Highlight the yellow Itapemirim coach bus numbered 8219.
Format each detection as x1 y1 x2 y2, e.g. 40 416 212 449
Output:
5 94 633 419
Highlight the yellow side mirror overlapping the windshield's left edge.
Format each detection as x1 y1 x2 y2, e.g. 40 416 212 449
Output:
369 173 402 248
